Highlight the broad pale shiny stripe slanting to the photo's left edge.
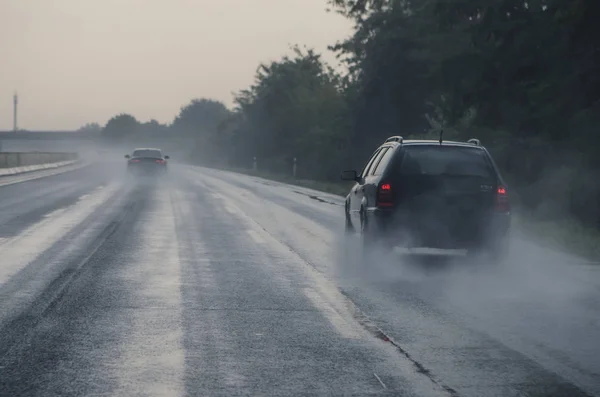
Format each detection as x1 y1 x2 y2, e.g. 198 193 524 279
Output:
0 185 119 285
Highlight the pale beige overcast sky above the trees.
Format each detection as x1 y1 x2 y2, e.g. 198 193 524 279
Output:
0 0 351 130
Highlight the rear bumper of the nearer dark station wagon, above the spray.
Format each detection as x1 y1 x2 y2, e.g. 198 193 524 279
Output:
366 208 511 249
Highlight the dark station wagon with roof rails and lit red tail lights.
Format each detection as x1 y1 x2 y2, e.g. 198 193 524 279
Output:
341 136 511 259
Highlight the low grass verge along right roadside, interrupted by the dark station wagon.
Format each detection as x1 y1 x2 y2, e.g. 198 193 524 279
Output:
217 168 600 261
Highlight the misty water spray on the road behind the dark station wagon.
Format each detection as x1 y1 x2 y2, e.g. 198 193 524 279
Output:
335 217 600 393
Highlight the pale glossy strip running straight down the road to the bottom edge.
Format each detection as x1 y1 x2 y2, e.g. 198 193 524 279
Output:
112 191 185 396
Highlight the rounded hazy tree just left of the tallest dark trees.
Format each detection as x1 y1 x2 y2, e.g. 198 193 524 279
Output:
229 46 350 179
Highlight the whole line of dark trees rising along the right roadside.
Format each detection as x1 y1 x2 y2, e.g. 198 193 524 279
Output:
94 0 600 228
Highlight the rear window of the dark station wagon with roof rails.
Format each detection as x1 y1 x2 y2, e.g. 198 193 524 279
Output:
400 145 494 178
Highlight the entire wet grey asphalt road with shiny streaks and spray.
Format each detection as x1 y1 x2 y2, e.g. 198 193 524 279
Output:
0 164 600 397
